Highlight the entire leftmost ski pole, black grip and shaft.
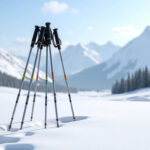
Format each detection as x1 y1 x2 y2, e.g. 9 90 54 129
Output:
8 26 39 131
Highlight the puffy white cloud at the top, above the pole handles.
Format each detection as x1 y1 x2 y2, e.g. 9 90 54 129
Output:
42 1 68 14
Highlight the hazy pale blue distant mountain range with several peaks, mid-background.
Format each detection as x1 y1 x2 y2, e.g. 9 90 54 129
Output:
54 42 120 76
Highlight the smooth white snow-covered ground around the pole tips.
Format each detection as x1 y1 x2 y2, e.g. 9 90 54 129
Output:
0 87 150 150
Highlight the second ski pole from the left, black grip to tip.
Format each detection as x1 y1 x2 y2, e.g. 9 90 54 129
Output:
20 27 45 129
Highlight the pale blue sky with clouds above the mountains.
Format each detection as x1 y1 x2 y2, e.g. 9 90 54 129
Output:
0 0 150 56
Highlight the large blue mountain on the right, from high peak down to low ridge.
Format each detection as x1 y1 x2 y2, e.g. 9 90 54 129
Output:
69 26 150 90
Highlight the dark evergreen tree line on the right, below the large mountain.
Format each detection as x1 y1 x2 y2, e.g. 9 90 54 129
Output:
111 67 150 94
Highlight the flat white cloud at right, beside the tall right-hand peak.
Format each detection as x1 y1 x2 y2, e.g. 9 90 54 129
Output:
112 26 142 37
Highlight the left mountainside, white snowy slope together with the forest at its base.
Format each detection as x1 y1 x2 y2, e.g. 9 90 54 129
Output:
0 48 77 92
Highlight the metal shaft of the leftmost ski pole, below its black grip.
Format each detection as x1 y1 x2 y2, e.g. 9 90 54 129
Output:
8 47 33 131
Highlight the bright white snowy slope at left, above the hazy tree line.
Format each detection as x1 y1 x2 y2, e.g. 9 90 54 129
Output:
0 48 51 80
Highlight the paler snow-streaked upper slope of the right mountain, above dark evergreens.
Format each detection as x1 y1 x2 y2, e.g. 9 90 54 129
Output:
105 26 150 78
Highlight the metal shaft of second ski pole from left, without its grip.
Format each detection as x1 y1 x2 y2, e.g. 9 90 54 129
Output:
20 48 39 129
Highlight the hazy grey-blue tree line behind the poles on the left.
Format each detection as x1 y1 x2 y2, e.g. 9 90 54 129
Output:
0 71 77 92
